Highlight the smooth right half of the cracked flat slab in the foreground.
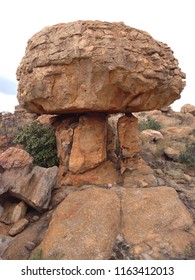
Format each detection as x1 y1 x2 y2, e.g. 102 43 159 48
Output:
122 187 193 244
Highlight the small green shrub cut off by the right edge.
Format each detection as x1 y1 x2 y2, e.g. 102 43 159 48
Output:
179 142 195 167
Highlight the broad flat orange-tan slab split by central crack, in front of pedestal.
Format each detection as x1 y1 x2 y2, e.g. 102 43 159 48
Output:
39 186 195 260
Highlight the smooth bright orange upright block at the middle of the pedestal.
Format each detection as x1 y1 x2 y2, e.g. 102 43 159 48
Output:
69 114 107 173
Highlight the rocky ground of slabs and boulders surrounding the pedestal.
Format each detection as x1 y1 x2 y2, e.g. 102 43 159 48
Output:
0 105 195 259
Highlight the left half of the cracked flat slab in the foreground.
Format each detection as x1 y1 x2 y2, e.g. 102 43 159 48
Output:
41 188 120 260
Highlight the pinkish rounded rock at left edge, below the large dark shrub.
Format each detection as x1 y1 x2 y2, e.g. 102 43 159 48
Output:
0 147 33 170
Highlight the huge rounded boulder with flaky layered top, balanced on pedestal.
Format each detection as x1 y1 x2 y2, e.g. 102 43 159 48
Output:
17 21 185 114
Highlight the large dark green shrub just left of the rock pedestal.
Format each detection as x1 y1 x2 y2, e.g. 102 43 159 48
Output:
14 121 58 167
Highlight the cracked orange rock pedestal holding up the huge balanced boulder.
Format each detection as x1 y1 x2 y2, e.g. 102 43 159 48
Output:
56 113 149 186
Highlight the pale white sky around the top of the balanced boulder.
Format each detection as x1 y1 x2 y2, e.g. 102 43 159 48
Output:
0 0 195 112
